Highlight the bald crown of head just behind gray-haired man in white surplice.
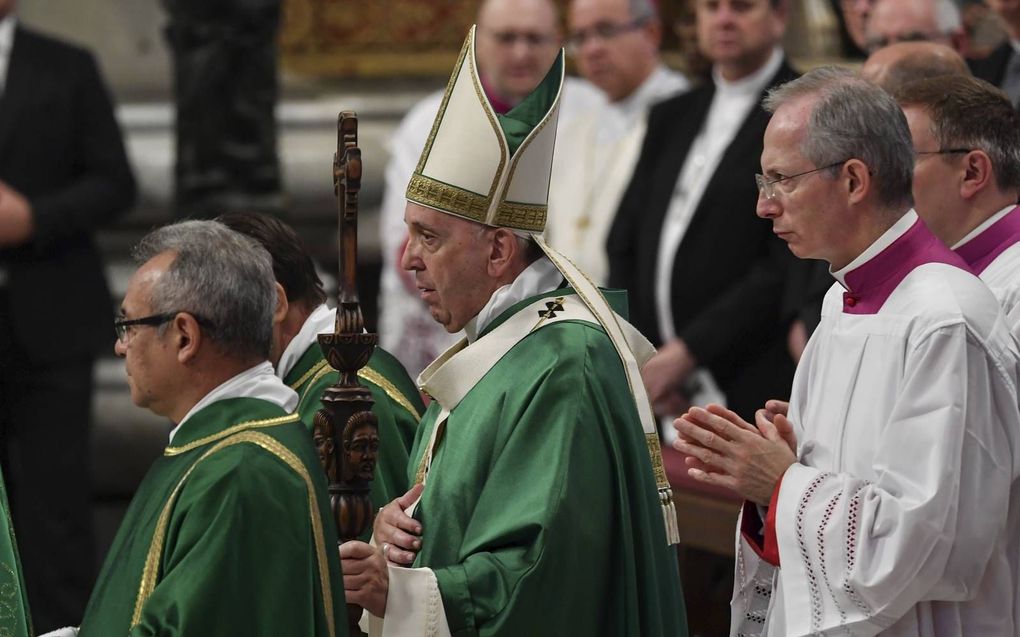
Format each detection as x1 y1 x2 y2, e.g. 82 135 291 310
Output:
861 42 970 93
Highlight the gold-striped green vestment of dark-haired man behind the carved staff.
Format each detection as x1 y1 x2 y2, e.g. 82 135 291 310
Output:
284 343 425 525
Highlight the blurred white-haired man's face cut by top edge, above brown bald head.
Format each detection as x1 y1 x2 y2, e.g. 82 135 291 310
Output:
865 0 966 53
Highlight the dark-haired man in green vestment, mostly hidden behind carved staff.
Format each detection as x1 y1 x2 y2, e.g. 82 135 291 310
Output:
218 212 425 529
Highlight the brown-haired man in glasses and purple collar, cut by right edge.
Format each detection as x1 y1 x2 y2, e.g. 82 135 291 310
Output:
895 76 1020 630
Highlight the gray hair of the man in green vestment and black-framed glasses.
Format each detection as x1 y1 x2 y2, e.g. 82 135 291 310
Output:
132 221 276 359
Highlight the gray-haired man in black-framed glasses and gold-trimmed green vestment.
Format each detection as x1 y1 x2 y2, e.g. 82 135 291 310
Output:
68 221 347 637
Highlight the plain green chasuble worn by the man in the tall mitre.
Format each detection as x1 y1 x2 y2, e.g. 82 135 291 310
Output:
409 289 686 637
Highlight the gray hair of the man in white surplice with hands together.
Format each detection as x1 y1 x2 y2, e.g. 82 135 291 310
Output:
763 66 914 208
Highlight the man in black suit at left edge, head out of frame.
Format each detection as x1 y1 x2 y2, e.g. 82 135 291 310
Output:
0 0 136 631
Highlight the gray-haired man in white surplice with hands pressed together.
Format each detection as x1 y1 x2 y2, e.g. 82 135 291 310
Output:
674 67 1020 637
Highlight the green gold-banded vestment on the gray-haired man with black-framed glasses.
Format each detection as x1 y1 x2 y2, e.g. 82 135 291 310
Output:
80 399 347 637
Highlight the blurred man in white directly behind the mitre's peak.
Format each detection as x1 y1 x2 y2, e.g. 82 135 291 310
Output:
378 0 601 377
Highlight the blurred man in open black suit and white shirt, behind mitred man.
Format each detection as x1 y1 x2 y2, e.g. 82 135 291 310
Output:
607 0 797 433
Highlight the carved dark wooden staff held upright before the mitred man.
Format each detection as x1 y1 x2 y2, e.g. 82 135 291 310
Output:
314 111 378 635
